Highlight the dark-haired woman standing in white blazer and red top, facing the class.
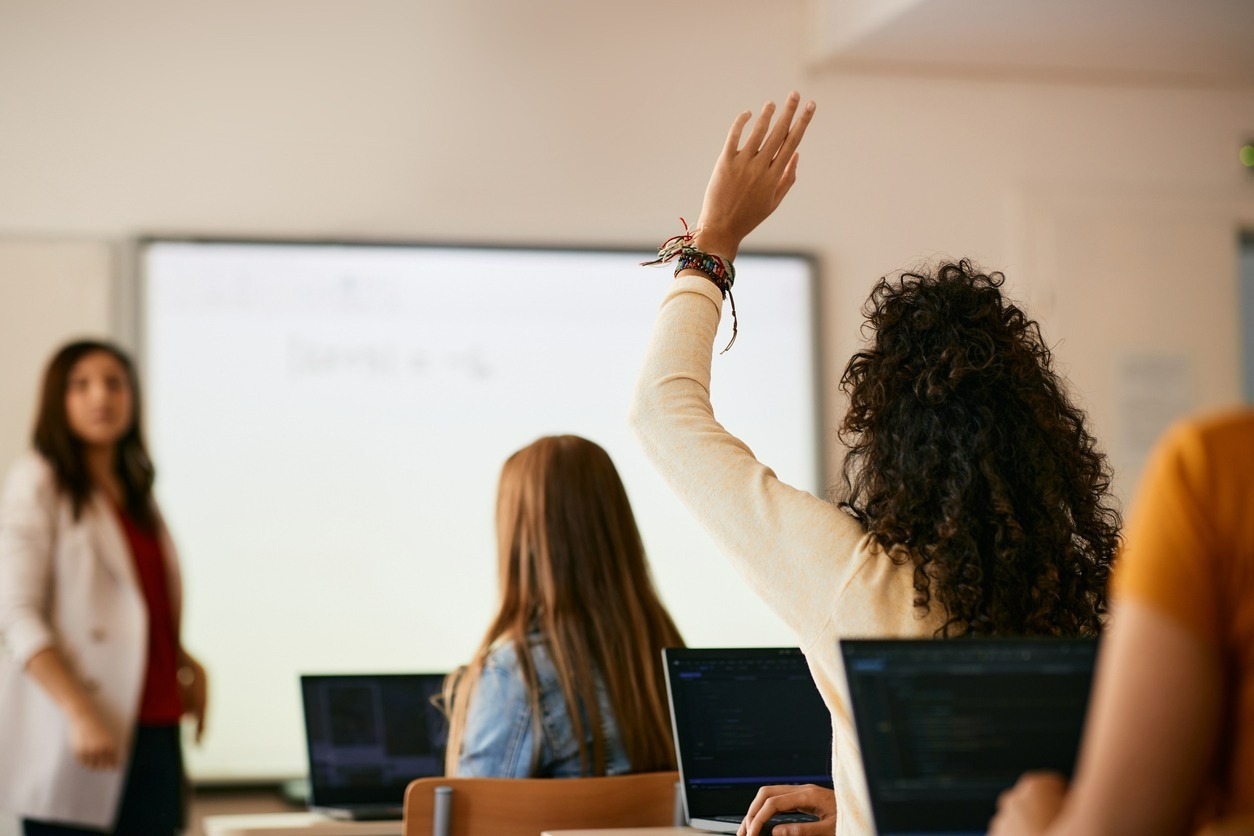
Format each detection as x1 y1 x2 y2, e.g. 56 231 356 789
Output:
0 341 207 836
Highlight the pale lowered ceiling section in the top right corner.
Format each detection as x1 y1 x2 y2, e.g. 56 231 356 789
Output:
814 0 1254 86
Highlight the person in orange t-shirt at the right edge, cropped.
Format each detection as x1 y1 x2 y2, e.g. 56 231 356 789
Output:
991 411 1254 836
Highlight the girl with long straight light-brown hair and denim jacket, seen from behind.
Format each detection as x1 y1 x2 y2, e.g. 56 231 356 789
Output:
445 435 683 778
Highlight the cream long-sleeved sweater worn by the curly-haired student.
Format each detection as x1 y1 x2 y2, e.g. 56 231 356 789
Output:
631 276 943 836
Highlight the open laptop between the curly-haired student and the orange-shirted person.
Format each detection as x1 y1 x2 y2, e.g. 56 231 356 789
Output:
840 638 1097 836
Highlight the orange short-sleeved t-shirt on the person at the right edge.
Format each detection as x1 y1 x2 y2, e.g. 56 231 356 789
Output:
1112 411 1254 816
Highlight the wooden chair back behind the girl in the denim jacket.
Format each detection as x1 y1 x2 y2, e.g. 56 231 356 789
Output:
404 772 683 836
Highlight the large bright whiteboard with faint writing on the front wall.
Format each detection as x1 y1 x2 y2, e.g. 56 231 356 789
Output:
138 241 823 782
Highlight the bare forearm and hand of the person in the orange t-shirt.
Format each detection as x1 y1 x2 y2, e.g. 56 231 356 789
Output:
989 600 1223 836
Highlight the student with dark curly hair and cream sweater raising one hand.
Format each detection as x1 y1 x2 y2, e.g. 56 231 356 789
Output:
631 93 1119 836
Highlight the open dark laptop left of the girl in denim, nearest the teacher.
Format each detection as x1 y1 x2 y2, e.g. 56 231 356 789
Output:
301 673 448 820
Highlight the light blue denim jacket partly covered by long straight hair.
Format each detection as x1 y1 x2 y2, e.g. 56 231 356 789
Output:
458 634 631 778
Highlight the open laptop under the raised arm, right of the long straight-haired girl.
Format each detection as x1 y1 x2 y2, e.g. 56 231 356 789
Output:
662 648 831 833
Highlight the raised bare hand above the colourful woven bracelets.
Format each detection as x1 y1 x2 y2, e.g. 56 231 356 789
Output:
696 90 815 258
